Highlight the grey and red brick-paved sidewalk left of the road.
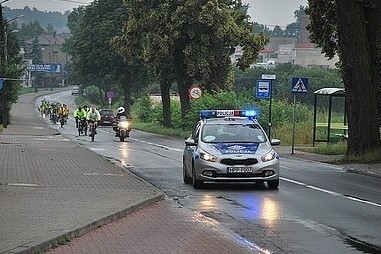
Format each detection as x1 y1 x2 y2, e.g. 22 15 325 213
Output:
0 90 262 254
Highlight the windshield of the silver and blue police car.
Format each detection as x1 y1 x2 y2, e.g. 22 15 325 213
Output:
201 124 267 143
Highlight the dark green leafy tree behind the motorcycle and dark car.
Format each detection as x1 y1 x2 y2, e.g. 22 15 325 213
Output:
65 0 142 113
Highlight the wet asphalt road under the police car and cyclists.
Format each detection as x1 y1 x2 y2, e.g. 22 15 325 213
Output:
38 92 381 253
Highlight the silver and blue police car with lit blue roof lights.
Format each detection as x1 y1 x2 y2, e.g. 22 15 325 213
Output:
183 110 280 189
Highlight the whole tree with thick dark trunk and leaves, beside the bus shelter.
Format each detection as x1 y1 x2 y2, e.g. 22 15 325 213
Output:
307 0 381 155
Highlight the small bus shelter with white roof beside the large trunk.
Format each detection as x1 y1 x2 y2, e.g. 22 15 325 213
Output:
312 87 348 146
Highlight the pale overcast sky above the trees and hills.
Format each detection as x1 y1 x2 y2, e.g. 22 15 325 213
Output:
3 0 307 28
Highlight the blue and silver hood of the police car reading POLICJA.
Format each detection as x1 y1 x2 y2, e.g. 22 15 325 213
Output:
201 142 272 156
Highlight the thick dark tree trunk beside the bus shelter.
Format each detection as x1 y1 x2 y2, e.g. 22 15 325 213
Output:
337 0 380 155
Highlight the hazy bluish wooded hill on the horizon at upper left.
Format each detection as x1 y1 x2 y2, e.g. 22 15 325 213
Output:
3 6 70 33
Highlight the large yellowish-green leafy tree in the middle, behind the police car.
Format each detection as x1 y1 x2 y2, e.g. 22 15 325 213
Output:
114 0 268 126
